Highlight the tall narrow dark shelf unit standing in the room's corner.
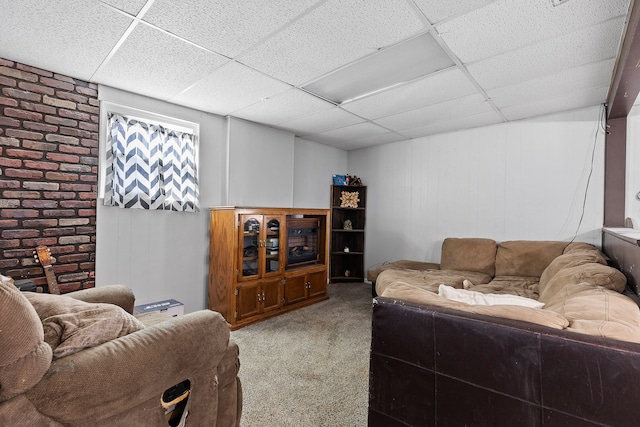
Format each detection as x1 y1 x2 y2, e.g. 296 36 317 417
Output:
329 185 367 283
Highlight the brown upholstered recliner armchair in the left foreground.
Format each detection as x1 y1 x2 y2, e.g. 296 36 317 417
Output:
0 284 242 427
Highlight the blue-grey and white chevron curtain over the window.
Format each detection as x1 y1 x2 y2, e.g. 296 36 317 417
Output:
104 113 199 212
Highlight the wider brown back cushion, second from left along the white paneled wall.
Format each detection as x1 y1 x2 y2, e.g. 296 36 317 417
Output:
495 240 568 277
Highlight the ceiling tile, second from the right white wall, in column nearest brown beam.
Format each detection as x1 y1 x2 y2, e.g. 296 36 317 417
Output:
487 59 615 108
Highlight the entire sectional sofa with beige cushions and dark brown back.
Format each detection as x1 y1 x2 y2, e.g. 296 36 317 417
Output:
368 239 640 427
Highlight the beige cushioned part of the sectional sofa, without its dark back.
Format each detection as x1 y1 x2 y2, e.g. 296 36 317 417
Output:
369 238 640 343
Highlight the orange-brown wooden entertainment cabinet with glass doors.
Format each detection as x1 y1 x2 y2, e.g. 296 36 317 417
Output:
208 207 329 329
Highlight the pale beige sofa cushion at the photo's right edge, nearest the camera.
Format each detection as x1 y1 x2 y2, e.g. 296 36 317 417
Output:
545 283 640 343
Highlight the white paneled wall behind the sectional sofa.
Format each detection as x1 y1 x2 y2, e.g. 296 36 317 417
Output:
349 107 604 274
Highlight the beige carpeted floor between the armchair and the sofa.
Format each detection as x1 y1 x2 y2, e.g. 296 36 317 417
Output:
231 283 372 427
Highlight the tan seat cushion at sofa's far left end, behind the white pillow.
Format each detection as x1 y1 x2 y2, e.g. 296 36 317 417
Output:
376 270 491 295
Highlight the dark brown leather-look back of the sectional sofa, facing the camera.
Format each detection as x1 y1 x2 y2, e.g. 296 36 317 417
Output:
369 297 640 427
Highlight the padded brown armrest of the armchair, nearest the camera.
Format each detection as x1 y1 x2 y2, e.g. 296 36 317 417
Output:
27 310 229 423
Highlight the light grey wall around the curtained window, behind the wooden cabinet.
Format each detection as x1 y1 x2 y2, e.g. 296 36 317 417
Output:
96 86 347 312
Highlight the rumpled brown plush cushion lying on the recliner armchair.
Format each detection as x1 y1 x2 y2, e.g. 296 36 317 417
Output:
25 292 144 360
